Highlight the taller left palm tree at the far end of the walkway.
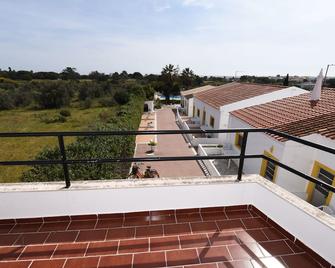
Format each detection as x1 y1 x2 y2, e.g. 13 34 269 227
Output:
157 64 180 101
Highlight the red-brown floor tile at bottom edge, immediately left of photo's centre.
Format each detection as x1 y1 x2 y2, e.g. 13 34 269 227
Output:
133 252 166 268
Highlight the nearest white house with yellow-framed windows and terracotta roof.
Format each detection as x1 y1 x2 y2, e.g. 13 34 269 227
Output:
229 89 335 210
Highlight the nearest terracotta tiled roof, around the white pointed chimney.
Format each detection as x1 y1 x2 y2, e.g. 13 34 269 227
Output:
231 88 335 140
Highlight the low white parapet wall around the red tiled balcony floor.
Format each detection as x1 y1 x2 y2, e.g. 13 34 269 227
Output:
0 175 335 264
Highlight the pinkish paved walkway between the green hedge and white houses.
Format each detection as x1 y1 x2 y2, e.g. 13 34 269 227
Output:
135 108 204 177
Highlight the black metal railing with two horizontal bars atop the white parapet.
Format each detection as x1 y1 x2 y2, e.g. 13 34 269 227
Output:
0 128 335 193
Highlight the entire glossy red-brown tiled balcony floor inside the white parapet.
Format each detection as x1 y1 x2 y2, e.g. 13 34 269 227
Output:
0 205 331 268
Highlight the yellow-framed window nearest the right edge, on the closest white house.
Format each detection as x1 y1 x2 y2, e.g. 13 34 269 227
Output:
307 161 335 207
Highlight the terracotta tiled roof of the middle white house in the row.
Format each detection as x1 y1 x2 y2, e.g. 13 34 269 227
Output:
194 82 286 109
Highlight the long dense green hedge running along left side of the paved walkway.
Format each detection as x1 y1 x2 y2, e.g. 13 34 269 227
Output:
22 95 145 182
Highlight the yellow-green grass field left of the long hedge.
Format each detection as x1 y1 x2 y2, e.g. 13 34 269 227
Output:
0 107 115 183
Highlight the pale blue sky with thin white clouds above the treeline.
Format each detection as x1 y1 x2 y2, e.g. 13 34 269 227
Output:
0 0 335 76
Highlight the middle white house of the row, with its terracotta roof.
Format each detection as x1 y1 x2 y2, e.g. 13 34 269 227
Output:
193 82 307 138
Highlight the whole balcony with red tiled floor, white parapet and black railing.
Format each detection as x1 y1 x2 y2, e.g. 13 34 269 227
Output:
0 129 335 268
